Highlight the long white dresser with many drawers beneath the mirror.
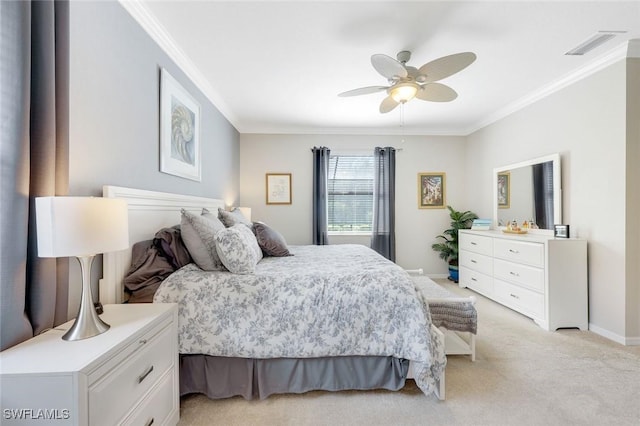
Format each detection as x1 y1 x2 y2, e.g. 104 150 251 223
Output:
459 230 589 330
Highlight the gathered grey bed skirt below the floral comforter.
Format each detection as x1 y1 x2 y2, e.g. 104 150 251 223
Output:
180 355 409 399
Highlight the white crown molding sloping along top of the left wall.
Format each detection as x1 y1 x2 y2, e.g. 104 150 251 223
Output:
119 0 238 129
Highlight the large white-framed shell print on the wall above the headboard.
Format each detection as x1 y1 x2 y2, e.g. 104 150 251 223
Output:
160 68 201 181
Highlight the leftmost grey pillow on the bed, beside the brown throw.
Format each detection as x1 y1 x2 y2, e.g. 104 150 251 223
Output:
180 209 224 271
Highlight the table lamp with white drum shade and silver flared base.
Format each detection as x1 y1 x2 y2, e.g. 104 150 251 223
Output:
36 197 129 341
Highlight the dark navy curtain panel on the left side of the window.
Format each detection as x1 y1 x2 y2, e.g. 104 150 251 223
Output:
311 146 331 245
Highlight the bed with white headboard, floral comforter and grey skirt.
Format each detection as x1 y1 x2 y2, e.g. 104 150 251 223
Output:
100 186 456 399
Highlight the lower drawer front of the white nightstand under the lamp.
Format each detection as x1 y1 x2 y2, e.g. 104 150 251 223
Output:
123 367 179 426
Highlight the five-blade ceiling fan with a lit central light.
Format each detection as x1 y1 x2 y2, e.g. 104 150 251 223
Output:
338 50 476 113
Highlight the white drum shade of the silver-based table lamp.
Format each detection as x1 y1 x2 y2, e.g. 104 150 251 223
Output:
36 197 129 257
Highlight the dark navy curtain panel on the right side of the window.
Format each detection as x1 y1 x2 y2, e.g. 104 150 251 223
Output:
371 147 396 262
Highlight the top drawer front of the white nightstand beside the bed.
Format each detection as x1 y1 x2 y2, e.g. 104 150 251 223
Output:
89 324 175 425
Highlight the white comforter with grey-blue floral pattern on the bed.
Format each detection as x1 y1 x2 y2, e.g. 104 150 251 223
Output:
154 244 446 395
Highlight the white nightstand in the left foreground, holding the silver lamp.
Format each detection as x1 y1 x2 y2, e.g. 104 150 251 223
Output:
0 303 180 426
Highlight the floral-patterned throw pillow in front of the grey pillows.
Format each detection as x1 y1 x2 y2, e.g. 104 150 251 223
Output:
215 223 262 274
